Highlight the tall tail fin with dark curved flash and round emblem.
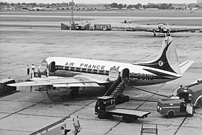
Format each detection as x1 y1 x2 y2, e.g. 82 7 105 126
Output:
136 37 191 75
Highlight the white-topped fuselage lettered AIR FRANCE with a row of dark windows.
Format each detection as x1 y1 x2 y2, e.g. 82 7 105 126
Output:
42 57 181 86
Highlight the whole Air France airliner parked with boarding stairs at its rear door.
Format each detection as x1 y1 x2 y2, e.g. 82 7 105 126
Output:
10 37 194 96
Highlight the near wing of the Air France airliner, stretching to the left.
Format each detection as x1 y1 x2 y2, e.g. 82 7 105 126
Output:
8 75 109 87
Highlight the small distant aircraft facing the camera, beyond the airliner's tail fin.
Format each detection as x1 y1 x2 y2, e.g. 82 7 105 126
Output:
135 23 200 36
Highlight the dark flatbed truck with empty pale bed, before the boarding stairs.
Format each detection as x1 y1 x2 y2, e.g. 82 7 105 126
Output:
95 96 150 122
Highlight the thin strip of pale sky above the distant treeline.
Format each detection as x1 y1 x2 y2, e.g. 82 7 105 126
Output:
0 0 197 4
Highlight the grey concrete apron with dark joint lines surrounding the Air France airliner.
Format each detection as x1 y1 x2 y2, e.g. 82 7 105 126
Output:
0 28 202 135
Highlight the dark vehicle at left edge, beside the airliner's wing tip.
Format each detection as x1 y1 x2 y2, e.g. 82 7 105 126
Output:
0 78 16 96
